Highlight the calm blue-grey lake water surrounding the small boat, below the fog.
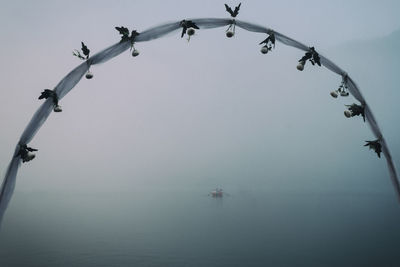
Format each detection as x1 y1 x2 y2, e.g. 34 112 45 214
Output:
0 190 400 267
